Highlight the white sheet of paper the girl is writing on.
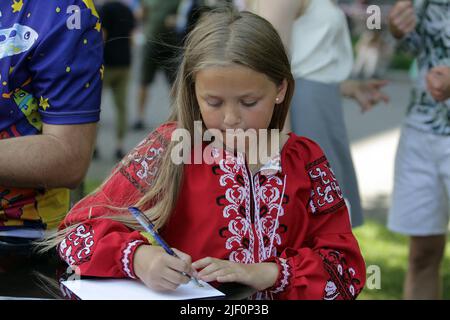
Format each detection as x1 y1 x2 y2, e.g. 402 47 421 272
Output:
62 279 225 300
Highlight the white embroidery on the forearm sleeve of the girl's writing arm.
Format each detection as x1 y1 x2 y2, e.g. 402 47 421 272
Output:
59 224 94 266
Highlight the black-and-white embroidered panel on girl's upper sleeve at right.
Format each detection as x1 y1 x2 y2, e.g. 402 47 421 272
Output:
306 157 345 214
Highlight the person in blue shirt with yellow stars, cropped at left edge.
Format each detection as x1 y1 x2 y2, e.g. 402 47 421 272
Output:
0 0 103 242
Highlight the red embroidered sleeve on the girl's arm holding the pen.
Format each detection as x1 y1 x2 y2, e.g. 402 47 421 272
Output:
58 126 174 278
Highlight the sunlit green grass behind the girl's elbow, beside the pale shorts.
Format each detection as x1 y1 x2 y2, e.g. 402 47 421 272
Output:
354 220 450 300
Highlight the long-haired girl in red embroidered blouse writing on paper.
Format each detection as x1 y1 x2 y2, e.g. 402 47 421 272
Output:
41 9 365 299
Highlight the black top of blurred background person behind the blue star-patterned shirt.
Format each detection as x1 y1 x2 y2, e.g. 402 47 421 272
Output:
99 1 135 67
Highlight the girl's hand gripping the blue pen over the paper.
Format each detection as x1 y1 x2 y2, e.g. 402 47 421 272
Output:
133 245 192 291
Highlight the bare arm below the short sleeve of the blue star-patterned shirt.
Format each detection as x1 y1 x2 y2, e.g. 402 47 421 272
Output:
0 123 96 188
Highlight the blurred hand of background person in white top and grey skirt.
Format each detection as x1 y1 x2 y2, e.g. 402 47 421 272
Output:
341 80 389 113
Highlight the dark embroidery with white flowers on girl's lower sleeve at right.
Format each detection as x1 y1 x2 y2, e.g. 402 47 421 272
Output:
319 250 361 300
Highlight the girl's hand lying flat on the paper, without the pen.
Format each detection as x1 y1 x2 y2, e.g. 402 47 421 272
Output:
192 257 278 291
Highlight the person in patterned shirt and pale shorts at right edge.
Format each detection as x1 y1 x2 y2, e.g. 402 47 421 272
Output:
388 0 450 299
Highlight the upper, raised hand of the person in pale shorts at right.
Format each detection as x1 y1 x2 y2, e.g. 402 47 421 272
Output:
389 0 417 39
